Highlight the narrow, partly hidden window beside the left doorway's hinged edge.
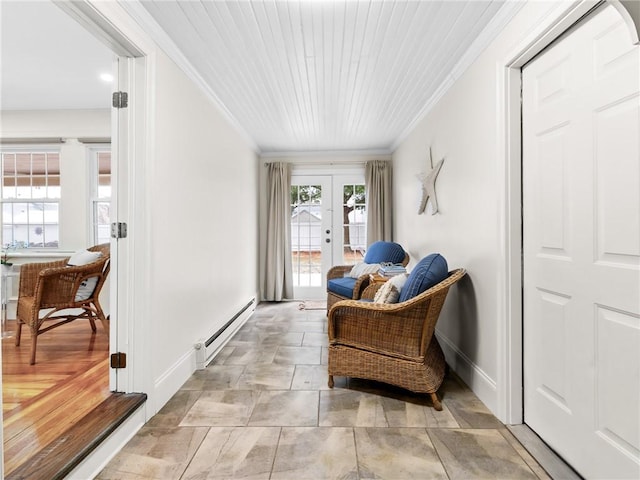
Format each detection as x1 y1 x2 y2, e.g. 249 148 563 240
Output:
90 147 111 245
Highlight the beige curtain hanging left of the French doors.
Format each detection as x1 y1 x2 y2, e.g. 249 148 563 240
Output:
264 162 293 302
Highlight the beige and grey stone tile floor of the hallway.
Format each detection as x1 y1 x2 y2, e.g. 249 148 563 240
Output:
97 302 550 480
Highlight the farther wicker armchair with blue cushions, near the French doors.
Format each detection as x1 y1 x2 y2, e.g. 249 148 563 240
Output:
327 241 409 312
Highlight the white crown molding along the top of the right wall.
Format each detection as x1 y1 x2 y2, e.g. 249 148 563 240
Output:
390 0 525 152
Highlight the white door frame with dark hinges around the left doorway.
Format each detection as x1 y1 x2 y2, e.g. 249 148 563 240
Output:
53 0 156 398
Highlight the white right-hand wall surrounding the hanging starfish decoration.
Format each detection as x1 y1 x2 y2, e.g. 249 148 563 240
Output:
393 2 557 420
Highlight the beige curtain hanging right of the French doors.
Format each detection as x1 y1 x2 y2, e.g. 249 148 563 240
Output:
365 160 393 245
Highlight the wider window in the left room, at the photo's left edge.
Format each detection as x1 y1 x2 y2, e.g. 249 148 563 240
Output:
2 150 60 248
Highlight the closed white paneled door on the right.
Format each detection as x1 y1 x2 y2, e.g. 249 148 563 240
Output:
522 7 640 479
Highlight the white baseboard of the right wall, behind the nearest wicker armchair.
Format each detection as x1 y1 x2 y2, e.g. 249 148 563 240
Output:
436 332 498 416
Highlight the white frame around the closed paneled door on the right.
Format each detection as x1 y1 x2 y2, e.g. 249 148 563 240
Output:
496 0 638 424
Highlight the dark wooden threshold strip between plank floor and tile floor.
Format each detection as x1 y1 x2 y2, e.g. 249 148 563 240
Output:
5 393 147 480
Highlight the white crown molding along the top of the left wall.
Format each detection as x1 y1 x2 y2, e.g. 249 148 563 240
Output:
119 0 261 155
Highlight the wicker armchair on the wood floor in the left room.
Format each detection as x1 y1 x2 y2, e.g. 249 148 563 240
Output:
16 244 110 365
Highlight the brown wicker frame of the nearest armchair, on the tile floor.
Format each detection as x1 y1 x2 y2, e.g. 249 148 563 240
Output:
328 268 465 410
